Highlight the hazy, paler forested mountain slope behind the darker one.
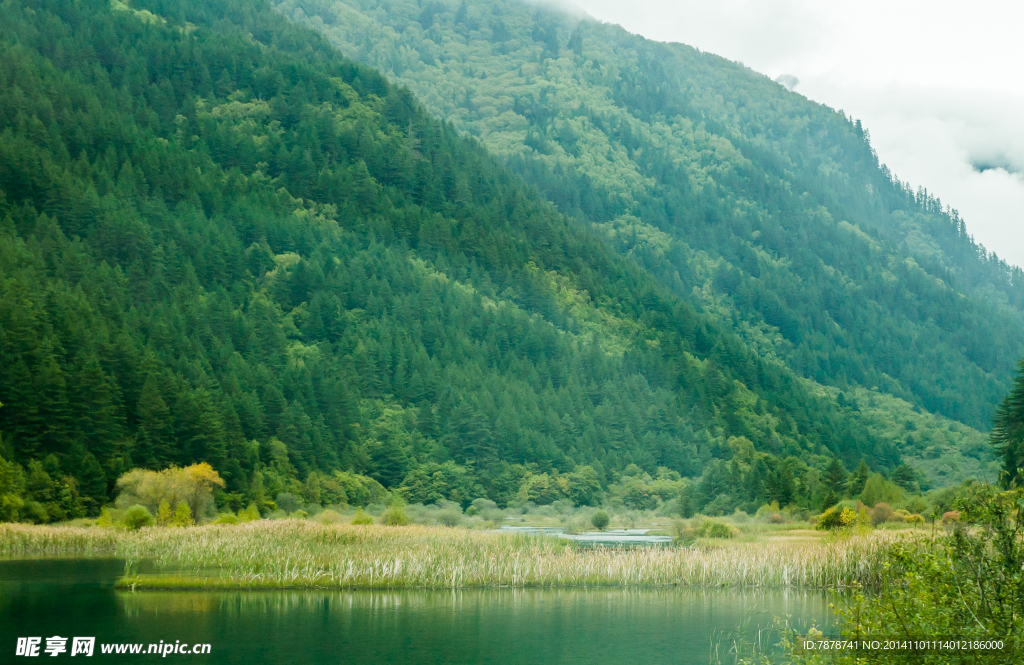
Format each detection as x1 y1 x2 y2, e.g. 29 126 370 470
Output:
276 0 1024 429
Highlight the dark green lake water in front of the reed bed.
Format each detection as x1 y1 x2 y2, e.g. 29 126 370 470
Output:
0 558 828 665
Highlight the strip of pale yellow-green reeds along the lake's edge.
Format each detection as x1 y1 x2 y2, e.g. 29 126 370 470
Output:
0 519 893 589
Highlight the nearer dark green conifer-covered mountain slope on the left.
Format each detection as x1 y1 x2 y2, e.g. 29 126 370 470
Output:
0 0 913 519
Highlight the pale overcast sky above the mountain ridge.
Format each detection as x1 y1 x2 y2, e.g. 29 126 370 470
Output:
569 0 1024 266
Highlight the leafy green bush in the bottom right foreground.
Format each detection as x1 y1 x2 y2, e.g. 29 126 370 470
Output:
794 485 1024 664
